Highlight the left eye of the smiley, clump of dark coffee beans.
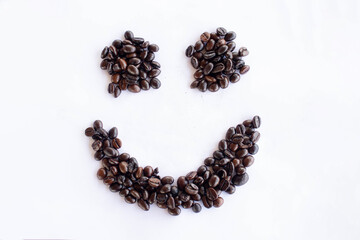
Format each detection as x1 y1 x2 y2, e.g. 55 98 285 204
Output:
100 31 161 97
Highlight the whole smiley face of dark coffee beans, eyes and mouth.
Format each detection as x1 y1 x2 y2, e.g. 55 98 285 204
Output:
85 28 261 216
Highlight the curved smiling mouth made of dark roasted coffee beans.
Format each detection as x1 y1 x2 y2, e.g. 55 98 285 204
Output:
85 116 261 216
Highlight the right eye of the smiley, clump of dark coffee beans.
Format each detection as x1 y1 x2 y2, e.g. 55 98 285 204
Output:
185 27 250 92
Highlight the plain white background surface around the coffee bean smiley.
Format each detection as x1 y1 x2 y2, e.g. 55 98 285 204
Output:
0 0 360 240
